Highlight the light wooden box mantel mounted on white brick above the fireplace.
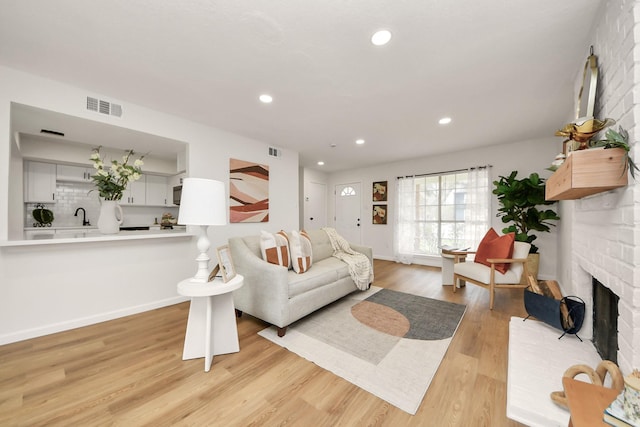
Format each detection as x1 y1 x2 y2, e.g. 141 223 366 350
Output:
545 148 628 200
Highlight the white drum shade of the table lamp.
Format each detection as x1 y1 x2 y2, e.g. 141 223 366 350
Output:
178 178 227 225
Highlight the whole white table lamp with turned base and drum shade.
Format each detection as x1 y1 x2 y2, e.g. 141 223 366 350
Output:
178 178 227 283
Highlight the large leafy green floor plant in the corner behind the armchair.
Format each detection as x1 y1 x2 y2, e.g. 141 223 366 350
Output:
493 171 560 254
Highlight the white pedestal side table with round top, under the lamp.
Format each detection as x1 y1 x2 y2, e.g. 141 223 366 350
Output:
178 274 244 372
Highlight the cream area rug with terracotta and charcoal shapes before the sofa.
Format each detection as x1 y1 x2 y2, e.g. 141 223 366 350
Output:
258 286 466 415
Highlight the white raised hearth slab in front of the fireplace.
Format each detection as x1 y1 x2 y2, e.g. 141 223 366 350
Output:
507 317 602 427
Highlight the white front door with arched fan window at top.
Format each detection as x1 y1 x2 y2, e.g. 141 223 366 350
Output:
334 182 362 243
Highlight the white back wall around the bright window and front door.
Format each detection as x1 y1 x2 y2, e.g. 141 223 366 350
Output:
328 136 561 278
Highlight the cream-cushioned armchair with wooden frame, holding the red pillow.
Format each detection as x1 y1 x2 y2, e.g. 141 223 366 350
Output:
453 242 531 310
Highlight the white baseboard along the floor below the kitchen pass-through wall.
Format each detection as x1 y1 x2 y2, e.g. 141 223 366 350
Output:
0 296 189 345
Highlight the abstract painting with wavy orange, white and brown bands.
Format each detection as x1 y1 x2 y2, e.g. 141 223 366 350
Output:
229 159 269 223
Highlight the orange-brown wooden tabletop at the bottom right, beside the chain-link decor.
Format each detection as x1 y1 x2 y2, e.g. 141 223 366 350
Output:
562 377 620 427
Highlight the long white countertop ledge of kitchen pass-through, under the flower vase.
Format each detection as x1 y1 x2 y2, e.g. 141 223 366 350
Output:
0 227 193 247
